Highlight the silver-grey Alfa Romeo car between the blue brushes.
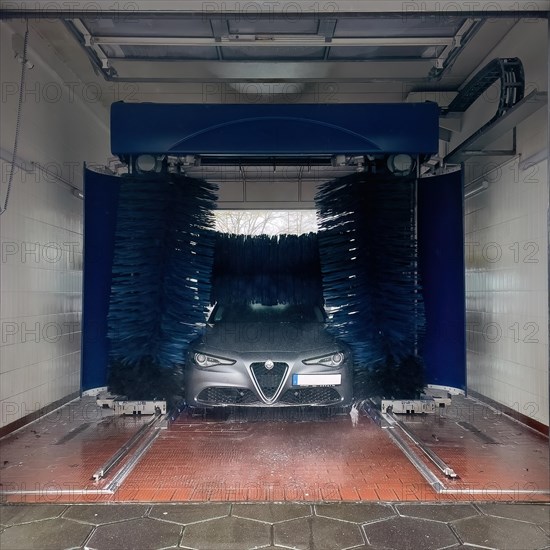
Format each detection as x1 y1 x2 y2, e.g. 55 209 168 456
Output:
185 304 353 407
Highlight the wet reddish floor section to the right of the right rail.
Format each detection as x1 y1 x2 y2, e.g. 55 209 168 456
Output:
404 396 550 500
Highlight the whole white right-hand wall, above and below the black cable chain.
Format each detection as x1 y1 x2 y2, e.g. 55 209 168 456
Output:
465 21 549 425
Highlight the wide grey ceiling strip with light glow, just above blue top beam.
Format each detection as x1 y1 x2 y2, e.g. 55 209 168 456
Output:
105 59 433 84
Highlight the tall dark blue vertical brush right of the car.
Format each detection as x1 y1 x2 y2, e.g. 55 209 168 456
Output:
316 173 425 397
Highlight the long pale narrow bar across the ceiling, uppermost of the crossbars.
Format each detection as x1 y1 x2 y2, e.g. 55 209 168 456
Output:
90 35 455 48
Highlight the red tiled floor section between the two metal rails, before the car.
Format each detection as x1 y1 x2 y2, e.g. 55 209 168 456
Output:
116 416 430 501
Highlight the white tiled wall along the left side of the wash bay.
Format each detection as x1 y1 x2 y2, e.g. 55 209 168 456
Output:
0 23 109 427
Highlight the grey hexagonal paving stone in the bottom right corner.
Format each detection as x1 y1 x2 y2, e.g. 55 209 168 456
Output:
453 516 550 550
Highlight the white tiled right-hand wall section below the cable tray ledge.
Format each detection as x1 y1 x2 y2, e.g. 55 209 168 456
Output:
465 155 548 424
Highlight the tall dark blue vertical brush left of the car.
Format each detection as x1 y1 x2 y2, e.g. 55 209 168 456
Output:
108 176 216 399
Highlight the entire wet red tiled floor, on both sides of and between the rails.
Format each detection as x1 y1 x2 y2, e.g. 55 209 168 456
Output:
0 398 550 502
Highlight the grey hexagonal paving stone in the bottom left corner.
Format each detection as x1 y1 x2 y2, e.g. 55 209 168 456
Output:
0 518 93 550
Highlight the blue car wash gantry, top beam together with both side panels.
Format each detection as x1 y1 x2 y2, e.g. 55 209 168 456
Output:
82 102 465 389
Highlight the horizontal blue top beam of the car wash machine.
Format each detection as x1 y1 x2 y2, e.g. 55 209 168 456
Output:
111 102 439 158
